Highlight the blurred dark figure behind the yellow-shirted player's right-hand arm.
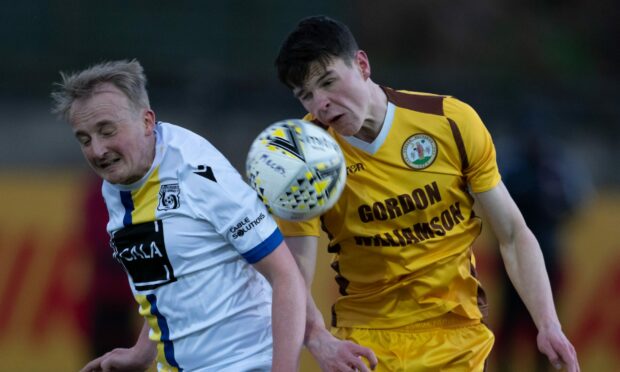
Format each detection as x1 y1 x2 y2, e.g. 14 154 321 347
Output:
494 130 588 372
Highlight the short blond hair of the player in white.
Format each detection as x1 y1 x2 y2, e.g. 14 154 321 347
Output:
51 59 151 121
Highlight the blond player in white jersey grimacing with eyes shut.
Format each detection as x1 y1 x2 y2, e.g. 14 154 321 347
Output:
52 60 306 372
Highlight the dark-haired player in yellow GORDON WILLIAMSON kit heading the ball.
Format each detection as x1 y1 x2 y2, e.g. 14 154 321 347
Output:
276 16 579 371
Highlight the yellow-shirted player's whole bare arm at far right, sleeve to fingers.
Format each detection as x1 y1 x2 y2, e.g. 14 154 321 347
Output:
475 182 579 372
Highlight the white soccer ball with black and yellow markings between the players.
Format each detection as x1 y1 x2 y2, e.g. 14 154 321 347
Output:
246 119 347 220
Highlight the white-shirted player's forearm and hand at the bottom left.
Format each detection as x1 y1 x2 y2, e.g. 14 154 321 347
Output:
80 321 157 372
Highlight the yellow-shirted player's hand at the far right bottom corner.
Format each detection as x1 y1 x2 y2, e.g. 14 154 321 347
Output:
536 324 580 372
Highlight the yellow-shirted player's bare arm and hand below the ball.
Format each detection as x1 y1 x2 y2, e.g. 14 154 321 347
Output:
286 236 377 372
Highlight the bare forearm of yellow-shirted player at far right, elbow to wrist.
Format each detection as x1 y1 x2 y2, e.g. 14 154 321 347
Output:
500 228 559 329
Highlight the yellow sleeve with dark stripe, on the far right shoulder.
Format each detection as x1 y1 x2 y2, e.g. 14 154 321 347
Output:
444 97 501 192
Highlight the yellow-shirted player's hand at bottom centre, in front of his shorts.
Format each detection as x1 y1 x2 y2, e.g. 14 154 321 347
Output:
307 332 378 372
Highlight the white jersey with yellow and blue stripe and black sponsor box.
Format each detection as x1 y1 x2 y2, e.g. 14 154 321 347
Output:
102 123 283 371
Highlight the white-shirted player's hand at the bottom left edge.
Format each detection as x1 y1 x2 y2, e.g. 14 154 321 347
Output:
80 348 155 372
